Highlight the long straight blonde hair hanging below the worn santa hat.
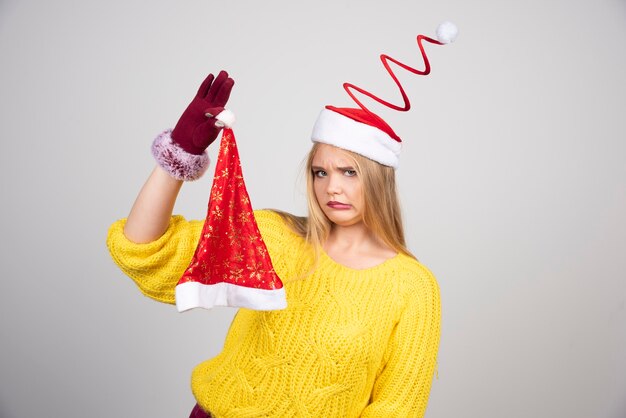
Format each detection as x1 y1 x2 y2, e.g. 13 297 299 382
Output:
276 142 415 258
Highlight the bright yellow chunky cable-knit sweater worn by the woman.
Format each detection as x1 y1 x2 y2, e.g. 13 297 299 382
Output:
107 211 440 418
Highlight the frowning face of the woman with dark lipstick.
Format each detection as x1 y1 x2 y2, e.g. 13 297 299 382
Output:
311 144 363 226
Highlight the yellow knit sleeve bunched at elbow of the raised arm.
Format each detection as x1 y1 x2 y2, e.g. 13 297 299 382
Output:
107 216 203 304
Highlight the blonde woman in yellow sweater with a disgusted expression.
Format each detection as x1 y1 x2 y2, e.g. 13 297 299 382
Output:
107 72 440 418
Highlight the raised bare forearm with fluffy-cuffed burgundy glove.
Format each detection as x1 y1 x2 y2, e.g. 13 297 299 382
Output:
119 71 235 243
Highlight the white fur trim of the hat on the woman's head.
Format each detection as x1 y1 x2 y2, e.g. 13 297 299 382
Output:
311 109 402 168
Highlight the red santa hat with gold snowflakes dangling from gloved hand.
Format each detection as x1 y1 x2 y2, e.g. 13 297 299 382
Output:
176 111 287 312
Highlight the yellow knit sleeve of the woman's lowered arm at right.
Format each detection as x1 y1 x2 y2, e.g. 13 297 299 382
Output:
361 265 441 418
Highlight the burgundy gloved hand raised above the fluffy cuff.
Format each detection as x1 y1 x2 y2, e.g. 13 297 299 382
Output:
172 71 235 155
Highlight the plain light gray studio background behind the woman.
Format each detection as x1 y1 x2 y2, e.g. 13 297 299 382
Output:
0 0 626 418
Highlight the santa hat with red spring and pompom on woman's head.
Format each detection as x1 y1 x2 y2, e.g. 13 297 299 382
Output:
311 22 458 168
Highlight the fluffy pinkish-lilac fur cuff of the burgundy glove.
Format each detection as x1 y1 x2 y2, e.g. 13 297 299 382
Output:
152 129 209 181
